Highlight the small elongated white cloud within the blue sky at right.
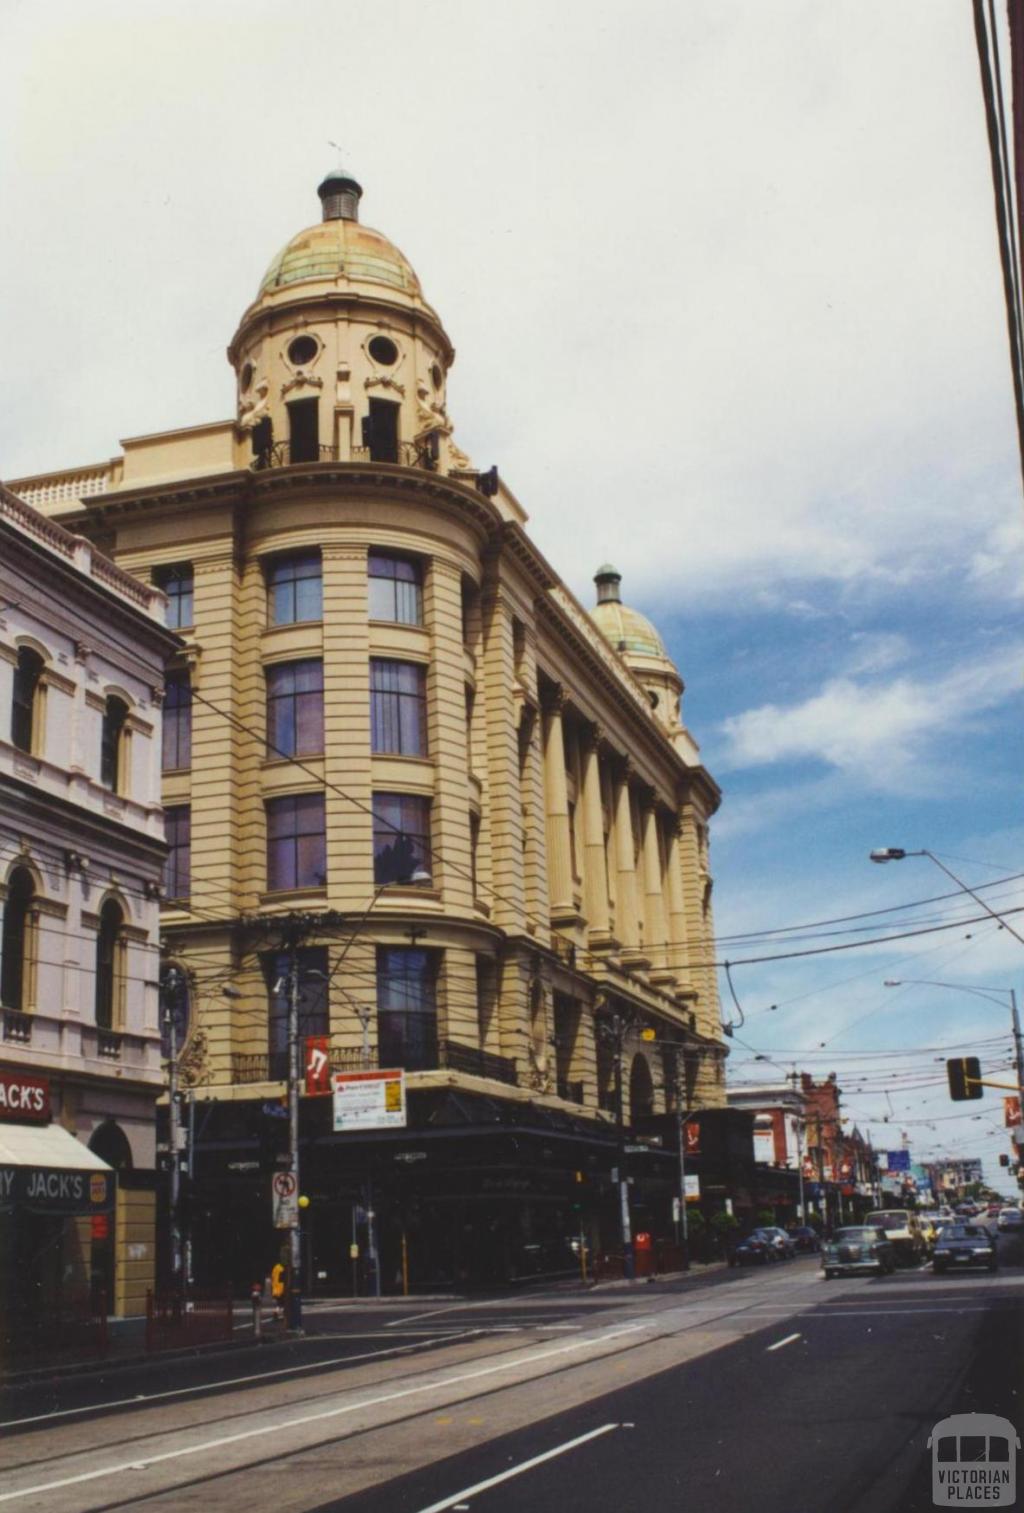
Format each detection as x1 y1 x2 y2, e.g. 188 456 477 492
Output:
720 646 1024 788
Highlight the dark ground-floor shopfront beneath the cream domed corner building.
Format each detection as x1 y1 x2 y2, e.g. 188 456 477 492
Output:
191 1089 678 1295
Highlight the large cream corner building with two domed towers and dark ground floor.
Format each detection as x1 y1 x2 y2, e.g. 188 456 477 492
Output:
14 171 725 1288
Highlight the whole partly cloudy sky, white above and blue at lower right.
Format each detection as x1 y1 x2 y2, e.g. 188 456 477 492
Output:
0 0 1024 1191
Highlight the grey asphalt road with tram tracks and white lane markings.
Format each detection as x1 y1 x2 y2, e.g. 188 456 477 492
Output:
0 1244 1024 1513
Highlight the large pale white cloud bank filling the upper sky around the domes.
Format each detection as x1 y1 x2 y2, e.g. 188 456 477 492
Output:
0 0 1015 607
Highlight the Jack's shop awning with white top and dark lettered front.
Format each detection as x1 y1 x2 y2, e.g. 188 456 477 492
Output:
0 1124 116 1213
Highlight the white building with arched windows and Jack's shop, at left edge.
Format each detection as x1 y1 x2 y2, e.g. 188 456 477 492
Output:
0 487 178 1356
